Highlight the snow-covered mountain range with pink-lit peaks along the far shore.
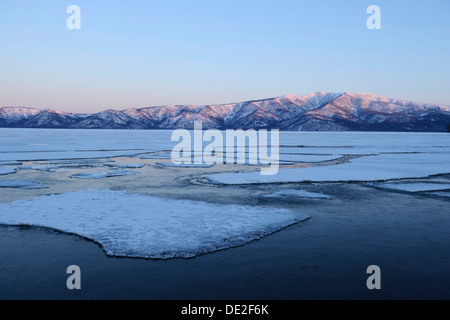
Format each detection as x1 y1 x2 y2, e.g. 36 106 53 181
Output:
0 92 450 132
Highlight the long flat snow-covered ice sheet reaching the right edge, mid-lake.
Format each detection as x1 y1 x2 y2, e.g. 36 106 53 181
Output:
208 153 450 184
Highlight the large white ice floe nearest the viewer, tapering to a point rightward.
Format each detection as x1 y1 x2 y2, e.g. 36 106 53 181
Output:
0 190 309 259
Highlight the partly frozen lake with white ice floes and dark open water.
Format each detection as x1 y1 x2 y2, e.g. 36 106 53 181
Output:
0 129 450 299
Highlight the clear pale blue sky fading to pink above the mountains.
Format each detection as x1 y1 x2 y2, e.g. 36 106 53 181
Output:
0 0 450 113
